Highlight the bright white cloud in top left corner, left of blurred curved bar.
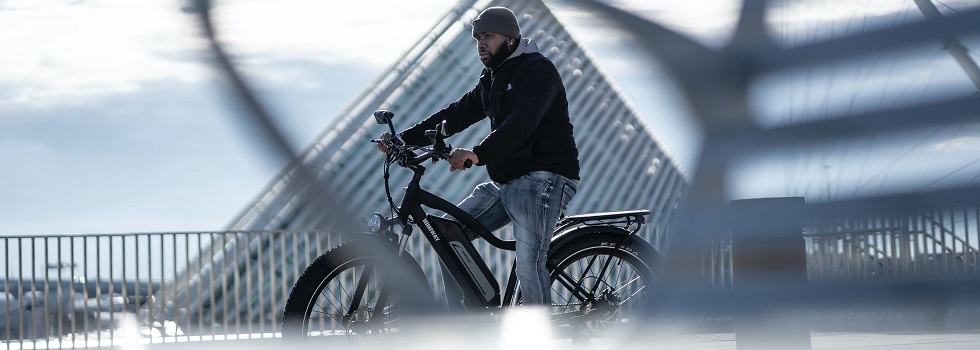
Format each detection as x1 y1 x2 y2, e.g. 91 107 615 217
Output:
0 1 206 107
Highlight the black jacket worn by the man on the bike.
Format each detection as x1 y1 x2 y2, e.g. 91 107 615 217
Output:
402 39 579 183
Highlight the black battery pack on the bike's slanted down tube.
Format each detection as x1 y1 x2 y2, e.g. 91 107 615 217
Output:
426 215 500 305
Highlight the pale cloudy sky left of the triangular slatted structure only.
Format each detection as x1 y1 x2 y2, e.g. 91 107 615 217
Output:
0 0 464 234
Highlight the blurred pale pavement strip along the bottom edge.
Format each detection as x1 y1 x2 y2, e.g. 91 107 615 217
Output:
0 317 980 350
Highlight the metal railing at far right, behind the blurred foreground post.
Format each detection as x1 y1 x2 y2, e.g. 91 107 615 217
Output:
702 206 980 288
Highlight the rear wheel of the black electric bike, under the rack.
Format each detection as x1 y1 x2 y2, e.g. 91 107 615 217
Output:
549 232 659 342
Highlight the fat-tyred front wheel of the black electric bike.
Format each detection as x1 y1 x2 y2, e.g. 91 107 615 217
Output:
282 239 431 344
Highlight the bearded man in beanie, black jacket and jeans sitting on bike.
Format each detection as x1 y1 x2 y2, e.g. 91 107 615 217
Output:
382 7 579 306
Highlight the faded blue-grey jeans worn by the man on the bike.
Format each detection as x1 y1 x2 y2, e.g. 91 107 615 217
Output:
446 171 578 306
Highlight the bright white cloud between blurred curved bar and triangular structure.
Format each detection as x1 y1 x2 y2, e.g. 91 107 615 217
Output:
214 0 456 69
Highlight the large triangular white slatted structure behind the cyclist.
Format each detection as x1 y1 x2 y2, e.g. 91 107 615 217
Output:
172 0 688 330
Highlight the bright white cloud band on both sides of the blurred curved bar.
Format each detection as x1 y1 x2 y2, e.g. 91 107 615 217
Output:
0 0 454 107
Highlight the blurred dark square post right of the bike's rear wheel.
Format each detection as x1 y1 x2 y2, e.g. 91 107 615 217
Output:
729 197 811 350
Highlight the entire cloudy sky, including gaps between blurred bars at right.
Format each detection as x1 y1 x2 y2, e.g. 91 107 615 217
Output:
0 0 980 235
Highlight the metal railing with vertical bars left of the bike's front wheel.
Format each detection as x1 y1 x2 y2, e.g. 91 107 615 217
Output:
0 231 345 348
